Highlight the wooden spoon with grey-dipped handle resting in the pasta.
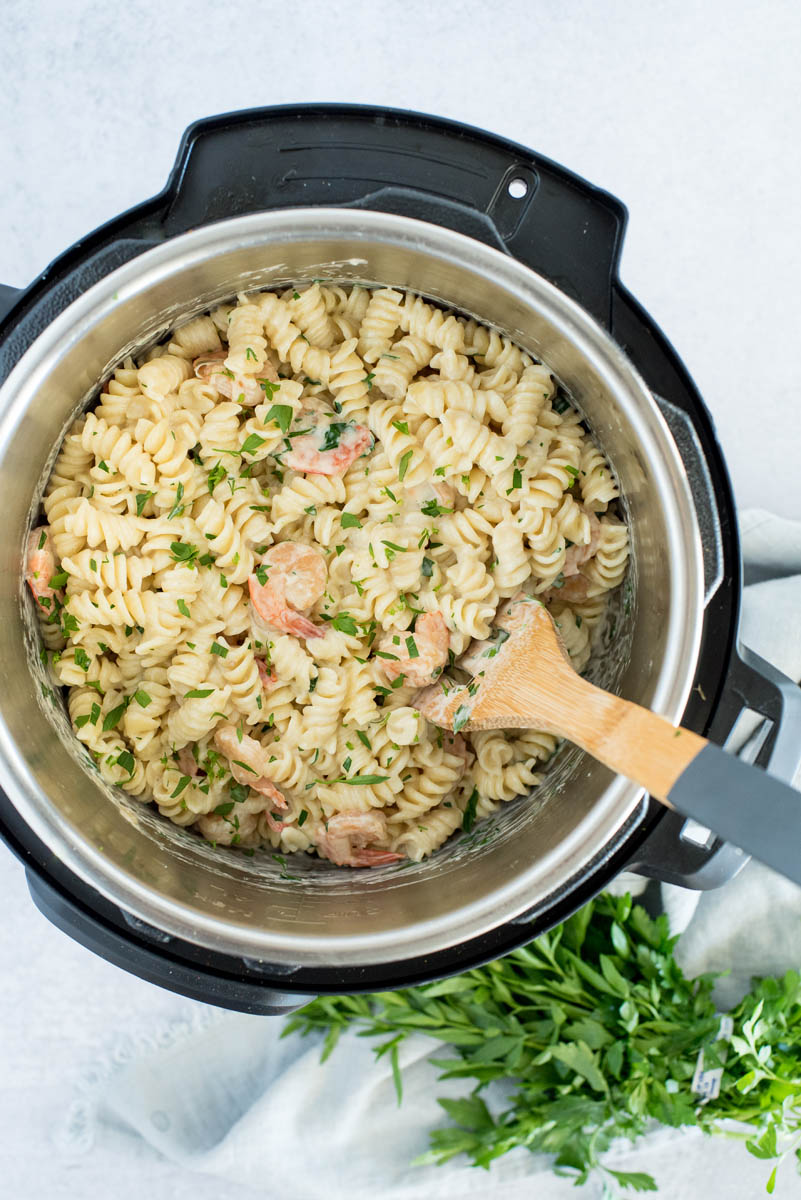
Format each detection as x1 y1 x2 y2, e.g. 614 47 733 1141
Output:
415 598 801 883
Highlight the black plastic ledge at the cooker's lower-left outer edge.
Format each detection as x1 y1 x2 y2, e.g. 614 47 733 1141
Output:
26 869 314 1016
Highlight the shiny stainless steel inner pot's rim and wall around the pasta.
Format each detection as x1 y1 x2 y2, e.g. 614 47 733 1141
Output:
0 208 704 966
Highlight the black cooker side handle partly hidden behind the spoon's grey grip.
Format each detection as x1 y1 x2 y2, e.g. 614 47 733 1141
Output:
625 646 801 890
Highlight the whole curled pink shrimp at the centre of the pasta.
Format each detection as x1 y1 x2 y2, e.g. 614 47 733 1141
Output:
248 541 327 638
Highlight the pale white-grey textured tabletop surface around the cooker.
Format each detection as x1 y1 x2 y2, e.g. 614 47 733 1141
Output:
0 0 801 1200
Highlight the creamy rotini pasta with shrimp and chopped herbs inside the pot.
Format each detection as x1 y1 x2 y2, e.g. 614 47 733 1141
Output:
28 283 628 866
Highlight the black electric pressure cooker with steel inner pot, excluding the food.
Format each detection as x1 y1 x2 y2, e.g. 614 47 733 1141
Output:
0 106 801 1013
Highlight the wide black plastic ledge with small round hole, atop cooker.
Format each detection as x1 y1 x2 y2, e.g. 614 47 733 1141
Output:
162 104 627 326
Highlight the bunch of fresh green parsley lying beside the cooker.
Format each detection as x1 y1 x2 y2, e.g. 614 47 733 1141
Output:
285 895 801 1196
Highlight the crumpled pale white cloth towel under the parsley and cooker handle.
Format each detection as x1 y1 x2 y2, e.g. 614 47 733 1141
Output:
60 511 801 1200
